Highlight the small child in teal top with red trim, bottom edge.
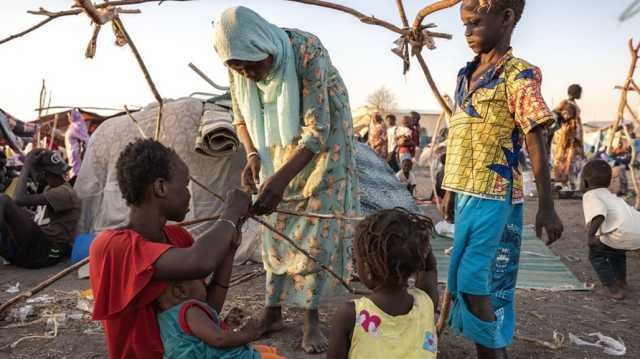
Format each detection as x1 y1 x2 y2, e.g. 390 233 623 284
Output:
157 279 284 359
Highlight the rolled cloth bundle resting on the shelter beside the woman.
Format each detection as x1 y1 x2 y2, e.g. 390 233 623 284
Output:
195 105 240 157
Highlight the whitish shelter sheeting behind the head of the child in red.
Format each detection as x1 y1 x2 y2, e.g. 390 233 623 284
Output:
74 98 245 242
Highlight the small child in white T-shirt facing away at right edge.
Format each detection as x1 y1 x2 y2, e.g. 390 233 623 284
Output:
582 160 640 300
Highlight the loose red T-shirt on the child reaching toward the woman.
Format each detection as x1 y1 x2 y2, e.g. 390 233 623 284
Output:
89 226 193 359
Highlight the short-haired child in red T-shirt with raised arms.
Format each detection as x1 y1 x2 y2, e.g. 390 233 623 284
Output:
89 140 250 358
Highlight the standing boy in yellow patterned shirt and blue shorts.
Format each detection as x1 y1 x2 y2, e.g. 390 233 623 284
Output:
443 0 562 358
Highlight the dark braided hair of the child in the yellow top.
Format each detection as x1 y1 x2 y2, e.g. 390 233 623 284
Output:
353 208 434 285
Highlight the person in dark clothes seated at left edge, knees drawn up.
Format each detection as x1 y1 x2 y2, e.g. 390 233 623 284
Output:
0 149 80 268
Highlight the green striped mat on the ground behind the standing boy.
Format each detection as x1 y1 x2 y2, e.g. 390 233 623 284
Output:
431 229 591 291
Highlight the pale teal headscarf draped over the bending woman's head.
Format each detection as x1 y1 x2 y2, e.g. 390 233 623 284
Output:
213 6 300 174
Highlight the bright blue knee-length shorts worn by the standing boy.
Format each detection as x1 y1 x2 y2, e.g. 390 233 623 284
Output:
448 195 523 349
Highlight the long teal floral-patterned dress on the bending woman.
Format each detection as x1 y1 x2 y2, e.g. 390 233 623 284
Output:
231 29 360 309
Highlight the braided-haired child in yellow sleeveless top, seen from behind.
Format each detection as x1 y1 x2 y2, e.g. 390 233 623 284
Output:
327 209 438 359
